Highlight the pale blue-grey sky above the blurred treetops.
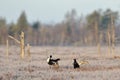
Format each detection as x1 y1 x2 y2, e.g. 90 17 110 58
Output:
0 0 120 23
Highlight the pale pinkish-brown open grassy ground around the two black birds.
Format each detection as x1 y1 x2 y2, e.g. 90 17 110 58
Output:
0 46 120 80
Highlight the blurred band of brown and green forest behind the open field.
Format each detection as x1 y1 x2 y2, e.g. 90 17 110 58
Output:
0 9 120 46
